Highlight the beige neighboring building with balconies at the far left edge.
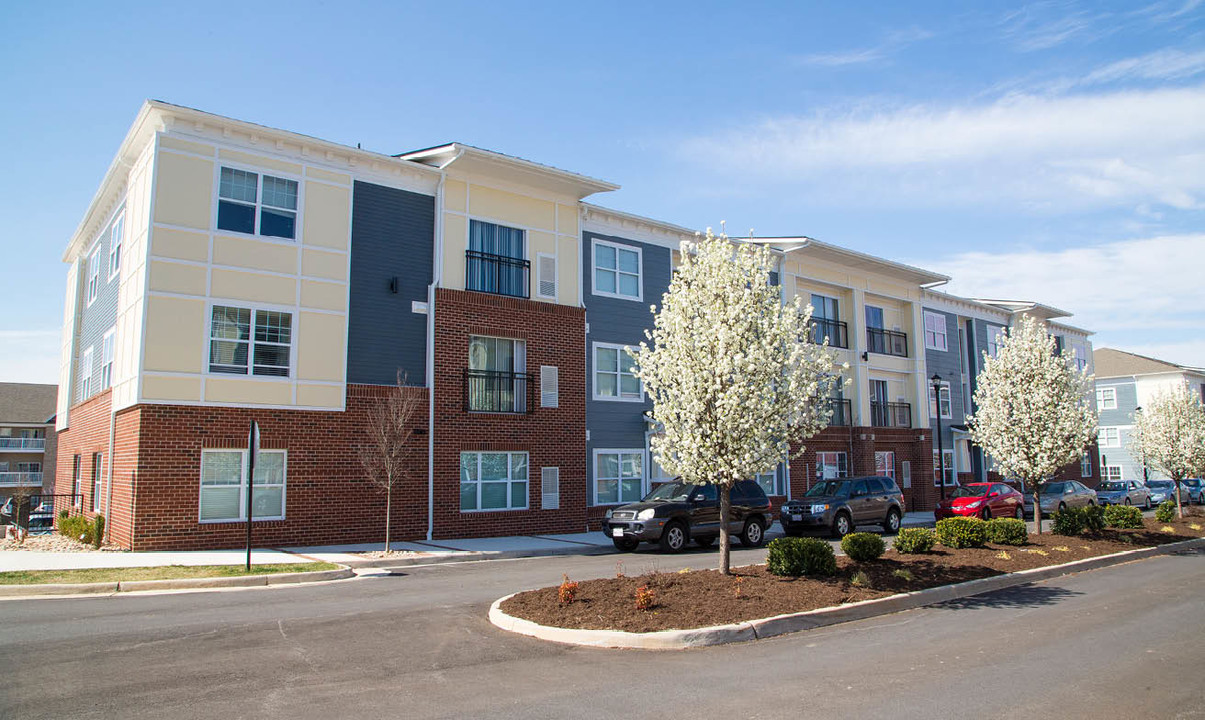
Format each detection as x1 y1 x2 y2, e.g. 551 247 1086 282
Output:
0 383 59 501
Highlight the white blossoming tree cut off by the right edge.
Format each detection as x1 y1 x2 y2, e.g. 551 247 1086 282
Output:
1130 384 1205 518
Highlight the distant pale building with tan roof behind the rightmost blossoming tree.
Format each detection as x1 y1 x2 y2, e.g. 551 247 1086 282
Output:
1093 348 1205 480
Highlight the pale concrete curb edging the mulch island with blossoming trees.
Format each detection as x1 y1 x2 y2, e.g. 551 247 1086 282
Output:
489 538 1205 650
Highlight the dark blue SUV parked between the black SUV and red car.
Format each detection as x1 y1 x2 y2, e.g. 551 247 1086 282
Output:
778 476 904 537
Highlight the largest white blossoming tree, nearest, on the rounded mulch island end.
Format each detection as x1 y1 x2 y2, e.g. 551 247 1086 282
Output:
631 229 841 574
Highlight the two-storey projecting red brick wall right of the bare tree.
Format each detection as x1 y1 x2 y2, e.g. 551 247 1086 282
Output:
434 289 587 538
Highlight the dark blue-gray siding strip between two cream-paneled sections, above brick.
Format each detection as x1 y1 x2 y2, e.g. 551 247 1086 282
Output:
347 182 435 385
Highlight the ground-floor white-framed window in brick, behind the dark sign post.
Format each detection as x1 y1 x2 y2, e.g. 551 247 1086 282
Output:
200 449 287 523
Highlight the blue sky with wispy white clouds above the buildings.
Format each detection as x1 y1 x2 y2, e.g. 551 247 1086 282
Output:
0 0 1205 382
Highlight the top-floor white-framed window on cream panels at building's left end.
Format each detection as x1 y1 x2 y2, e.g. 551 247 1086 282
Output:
218 167 298 240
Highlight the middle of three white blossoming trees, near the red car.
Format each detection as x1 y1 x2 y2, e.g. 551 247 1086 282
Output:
968 315 1097 535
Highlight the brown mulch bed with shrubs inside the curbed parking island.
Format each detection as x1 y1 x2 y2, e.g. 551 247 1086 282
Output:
501 515 1205 632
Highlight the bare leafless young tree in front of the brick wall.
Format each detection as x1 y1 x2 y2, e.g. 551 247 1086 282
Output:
359 371 423 553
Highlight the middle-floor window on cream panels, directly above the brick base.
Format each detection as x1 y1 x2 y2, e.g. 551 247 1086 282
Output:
210 305 293 377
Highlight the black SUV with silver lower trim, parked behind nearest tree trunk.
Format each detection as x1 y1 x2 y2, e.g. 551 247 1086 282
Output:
603 480 774 553
